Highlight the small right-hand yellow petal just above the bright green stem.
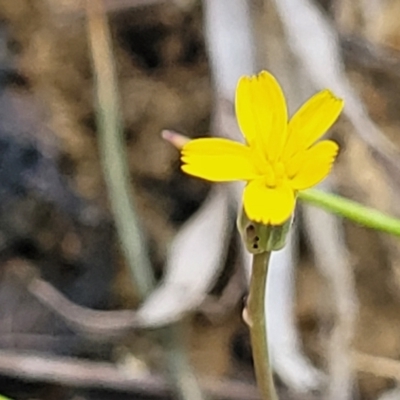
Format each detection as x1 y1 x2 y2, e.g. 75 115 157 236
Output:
291 140 339 190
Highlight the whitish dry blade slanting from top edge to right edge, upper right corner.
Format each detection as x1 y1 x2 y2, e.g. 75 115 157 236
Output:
274 0 400 194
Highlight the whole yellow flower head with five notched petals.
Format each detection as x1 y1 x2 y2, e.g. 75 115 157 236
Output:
182 71 343 225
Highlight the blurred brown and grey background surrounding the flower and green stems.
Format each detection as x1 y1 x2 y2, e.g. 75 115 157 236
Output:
0 0 400 400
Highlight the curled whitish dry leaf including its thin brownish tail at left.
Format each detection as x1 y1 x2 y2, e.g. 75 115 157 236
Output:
10 187 233 334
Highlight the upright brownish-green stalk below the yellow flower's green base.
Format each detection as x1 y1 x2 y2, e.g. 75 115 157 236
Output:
247 252 278 400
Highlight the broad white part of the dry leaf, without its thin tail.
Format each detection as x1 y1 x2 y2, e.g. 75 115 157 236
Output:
137 186 233 327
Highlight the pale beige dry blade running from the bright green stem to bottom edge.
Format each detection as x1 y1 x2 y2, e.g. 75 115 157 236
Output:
303 183 357 400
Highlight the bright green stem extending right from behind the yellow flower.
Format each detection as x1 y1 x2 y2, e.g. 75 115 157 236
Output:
298 189 400 236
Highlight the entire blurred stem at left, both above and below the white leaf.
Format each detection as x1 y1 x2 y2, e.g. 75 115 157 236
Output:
86 0 203 400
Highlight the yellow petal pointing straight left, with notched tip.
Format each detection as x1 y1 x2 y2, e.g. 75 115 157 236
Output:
181 138 258 182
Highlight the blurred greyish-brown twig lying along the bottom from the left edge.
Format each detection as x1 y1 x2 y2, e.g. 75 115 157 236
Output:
0 350 260 400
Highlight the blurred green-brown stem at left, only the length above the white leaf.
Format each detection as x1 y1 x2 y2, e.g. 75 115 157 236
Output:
87 0 154 298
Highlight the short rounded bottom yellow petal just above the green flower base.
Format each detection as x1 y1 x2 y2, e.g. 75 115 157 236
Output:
243 178 295 225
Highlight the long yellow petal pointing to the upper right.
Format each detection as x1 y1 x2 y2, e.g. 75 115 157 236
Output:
283 90 344 160
